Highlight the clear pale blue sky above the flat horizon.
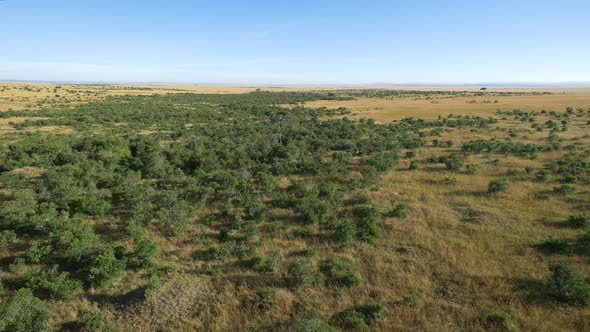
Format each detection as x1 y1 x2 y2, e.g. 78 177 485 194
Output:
0 0 590 84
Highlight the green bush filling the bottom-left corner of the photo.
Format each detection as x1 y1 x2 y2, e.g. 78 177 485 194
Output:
0 288 52 332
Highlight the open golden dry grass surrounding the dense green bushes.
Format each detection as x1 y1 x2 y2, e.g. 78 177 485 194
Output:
0 83 590 331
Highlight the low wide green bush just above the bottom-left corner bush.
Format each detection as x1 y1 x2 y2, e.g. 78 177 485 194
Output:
24 265 82 299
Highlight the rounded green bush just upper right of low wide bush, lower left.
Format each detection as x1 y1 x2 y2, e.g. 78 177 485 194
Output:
88 246 125 288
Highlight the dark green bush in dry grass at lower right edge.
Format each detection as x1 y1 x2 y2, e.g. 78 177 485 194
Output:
546 263 590 307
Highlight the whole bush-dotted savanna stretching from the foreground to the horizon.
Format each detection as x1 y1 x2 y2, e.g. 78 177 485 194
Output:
0 83 590 331
